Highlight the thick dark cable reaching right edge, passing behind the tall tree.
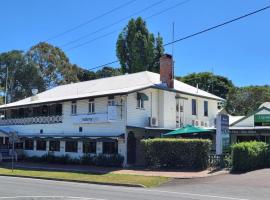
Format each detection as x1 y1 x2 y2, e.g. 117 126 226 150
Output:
88 5 270 70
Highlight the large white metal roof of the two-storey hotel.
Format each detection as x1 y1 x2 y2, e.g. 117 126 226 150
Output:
0 71 224 109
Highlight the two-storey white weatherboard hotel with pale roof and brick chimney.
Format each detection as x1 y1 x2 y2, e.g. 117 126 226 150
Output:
0 55 223 164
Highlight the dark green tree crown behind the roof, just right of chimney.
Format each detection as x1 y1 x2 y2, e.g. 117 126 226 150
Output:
177 72 234 99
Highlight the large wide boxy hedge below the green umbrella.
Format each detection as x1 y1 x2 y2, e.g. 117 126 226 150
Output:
141 138 211 170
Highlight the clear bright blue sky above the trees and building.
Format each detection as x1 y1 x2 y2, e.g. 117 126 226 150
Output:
0 0 270 86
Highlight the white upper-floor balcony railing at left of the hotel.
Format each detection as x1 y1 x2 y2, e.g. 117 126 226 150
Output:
0 115 63 126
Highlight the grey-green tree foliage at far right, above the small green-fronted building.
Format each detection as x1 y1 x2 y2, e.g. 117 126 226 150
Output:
225 85 270 115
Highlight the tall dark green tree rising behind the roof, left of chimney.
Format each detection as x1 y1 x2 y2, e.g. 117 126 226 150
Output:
116 17 164 73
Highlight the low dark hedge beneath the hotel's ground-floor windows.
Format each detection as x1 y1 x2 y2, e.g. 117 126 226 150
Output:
22 153 124 167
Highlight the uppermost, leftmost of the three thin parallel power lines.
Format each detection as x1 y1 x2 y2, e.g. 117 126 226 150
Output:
45 0 137 42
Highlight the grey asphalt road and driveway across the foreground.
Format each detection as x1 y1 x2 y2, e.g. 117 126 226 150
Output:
0 169 270 200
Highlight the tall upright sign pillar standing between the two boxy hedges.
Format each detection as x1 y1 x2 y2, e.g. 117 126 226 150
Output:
216 114 230 155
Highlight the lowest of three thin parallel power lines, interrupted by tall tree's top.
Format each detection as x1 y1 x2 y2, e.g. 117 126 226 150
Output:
66 0 191 51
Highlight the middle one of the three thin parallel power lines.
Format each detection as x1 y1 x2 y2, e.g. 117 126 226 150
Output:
60 0 167 48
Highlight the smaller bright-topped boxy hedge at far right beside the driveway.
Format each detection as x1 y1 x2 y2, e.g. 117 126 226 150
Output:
232 141 270 172
